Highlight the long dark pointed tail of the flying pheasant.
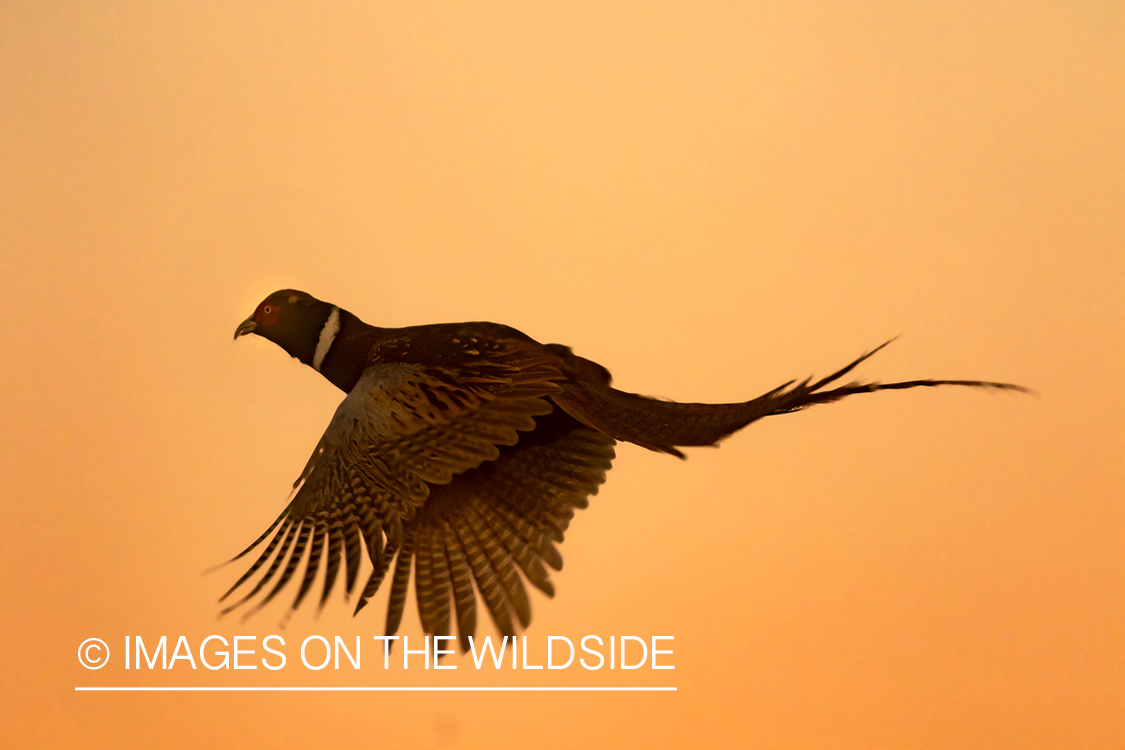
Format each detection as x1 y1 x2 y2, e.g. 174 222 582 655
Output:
551 340 1027 458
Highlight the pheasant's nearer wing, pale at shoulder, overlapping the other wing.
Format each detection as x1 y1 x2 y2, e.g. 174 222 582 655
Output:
221 340 563 616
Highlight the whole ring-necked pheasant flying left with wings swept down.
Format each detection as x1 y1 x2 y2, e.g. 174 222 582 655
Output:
221 289 1024 651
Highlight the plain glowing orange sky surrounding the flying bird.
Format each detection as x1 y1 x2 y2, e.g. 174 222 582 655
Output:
0 2 1125 748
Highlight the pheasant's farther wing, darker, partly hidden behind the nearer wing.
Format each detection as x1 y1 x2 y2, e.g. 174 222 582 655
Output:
387 410 614 651
